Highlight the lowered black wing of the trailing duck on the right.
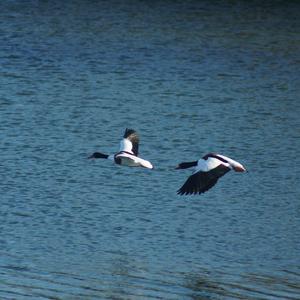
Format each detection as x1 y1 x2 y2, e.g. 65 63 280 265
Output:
177 164 230 195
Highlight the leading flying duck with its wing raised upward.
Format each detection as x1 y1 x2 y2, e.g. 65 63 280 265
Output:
89 128 153 169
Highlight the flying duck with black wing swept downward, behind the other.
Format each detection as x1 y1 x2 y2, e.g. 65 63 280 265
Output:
176 153 246 195
